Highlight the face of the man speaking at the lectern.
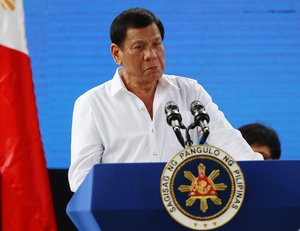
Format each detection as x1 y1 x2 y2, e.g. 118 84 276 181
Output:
112 23 165 83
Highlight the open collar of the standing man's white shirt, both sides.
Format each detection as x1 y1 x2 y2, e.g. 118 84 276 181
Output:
111 67 180 96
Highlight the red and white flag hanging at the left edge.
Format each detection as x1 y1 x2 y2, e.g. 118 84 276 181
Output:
0 0 57 231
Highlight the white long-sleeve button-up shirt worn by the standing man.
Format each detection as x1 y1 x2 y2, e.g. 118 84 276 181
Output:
69 69 263 191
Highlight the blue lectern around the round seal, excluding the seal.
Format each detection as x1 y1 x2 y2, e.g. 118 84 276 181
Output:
67 160 300 231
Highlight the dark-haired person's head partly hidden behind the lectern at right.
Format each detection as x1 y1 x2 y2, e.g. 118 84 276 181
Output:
239 123 281 160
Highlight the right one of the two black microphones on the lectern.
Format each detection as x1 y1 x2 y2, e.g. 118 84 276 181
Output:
191 100 209 144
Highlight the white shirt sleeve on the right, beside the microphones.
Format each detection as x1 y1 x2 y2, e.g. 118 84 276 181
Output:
194 83 263 160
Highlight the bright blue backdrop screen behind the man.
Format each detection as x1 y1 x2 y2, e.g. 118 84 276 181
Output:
24 0 300 168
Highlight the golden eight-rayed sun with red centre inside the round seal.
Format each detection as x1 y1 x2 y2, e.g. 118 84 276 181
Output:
178 163 227 213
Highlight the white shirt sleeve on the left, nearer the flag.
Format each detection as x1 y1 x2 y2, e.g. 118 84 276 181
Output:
68 94 104 192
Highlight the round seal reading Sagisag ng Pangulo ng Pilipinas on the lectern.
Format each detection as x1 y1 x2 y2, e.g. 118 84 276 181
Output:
160 145 245 230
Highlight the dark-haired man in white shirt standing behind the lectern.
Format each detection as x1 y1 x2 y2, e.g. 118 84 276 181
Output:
69 8 262 191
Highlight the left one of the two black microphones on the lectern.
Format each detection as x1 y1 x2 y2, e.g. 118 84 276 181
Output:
165 101 185 148
